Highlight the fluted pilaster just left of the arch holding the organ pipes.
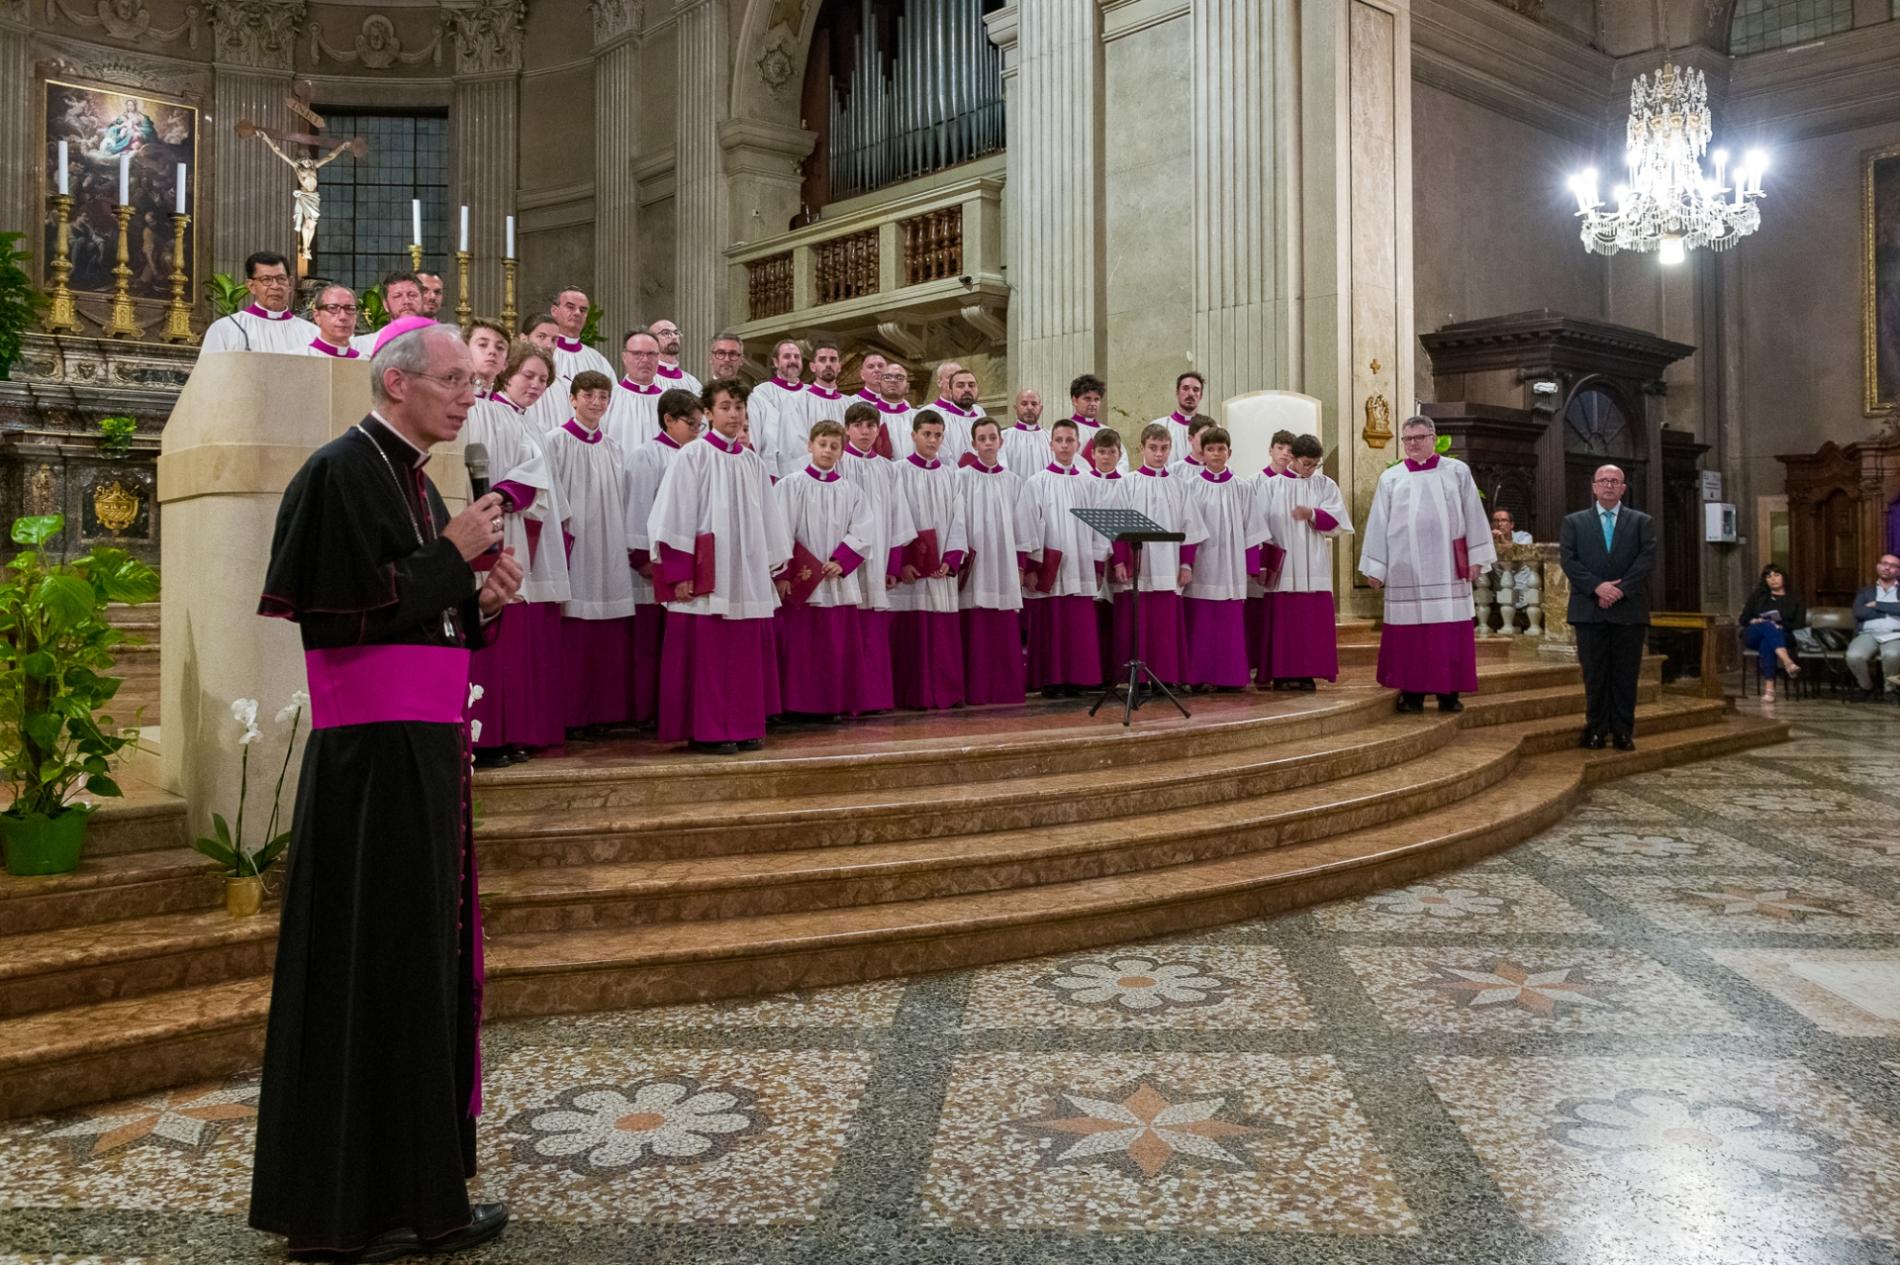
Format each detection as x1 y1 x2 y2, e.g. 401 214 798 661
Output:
673 0 732 346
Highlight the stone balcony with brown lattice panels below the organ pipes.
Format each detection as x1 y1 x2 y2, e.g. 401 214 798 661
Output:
726 175 1009 340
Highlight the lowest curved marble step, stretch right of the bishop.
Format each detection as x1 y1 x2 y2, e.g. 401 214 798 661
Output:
486 718 1788 1016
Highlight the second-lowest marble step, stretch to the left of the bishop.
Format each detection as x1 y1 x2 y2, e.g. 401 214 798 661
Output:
0 908 277 1018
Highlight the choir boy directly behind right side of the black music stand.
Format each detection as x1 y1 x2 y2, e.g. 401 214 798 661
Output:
1113 424 1207 686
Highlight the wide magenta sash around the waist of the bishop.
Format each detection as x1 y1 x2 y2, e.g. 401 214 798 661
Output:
304 646 469 729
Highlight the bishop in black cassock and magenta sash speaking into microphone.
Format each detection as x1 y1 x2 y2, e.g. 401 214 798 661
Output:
251 325 521 1261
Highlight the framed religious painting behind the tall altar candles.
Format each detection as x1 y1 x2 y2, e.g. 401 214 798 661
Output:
40 78 200 302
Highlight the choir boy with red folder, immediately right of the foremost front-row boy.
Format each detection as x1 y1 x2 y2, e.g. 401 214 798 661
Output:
771 418 884 720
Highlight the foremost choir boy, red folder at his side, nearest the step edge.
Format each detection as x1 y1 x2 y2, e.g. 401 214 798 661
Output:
648 378 792 754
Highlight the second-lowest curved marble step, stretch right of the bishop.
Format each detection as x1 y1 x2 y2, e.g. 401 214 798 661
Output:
483 735 1518 935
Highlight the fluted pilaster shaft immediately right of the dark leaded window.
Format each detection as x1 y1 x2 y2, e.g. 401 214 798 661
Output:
443 72 521 319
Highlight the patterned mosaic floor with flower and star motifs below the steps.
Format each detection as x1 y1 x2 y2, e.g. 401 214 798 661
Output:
0 703 1900 1265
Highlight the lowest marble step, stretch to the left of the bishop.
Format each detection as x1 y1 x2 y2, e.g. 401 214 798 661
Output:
0 976 270 1119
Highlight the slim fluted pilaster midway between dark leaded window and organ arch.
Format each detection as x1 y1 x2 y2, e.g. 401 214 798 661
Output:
593 4 648 345
